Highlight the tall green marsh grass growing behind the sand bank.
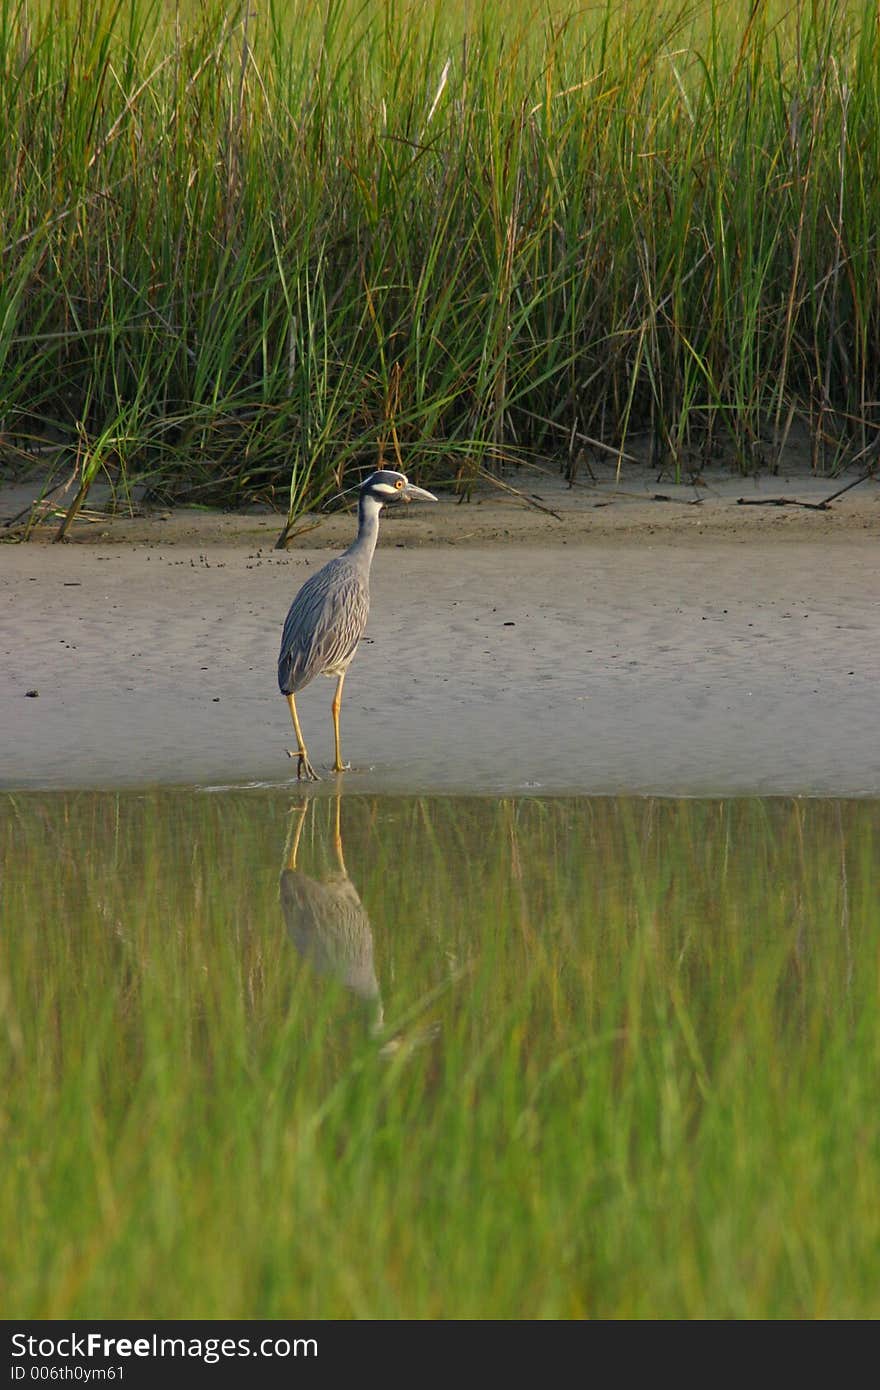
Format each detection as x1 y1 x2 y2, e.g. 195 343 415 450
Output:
0 0 880 518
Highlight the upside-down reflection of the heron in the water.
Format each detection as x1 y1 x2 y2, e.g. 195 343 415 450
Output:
279 795 439 1058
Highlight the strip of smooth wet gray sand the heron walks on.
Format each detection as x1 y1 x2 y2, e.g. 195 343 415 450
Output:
0 473 880 796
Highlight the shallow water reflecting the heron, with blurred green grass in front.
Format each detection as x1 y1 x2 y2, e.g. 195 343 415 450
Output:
0 790 880 1318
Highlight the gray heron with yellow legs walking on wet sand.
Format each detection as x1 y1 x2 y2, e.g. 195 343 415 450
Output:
278 468 437 781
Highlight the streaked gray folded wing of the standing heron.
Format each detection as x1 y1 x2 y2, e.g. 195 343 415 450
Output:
278 557 370 695
